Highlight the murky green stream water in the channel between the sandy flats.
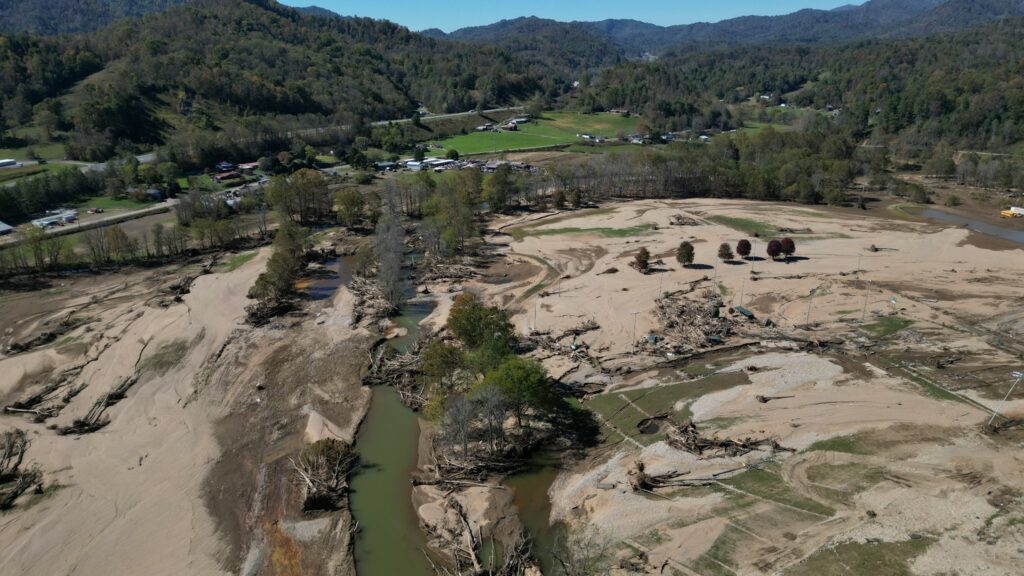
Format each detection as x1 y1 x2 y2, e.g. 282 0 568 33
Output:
306 256 559 576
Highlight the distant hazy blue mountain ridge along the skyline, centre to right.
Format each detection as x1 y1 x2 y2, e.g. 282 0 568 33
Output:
429 0 1024 57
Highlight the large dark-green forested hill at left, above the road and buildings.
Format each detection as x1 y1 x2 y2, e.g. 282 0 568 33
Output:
0 0 567 159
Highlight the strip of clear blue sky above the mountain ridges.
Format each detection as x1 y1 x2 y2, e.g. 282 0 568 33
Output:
279 0 863 32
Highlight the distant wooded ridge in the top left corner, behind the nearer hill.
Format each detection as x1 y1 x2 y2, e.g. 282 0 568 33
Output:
0 0 188 35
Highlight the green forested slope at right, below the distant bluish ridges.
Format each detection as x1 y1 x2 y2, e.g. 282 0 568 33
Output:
582 18 1024 154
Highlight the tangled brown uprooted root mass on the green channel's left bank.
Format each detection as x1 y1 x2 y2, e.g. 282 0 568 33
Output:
292 438 358 510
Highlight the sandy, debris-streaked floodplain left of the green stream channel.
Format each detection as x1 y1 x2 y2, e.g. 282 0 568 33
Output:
0 249 371 576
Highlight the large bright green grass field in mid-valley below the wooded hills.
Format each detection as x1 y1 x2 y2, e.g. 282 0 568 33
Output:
433 112 638 155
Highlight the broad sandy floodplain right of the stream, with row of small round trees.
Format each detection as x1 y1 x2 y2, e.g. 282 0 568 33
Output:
468 200 1024 575
